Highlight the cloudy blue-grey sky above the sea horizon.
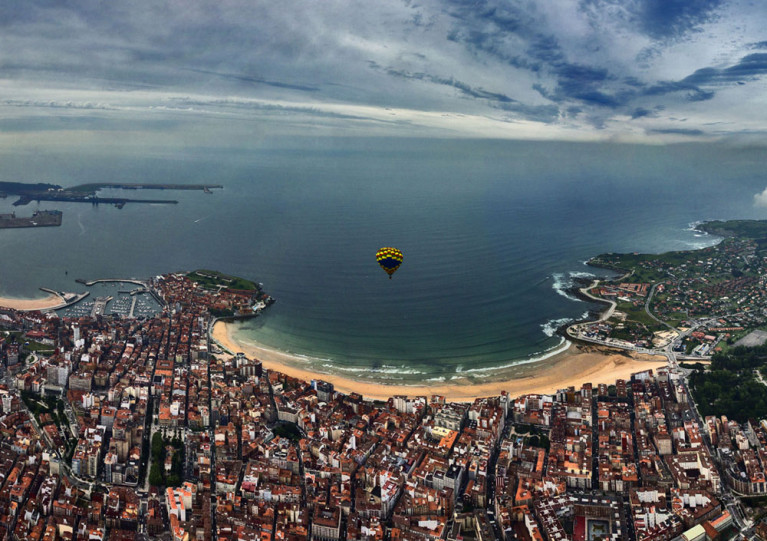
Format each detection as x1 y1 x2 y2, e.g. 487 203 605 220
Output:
0 0 767 143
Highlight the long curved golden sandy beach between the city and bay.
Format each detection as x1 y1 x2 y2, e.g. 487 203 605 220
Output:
211 321 666 402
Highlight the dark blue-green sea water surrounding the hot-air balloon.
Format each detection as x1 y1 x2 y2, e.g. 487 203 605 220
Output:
0 138 767 383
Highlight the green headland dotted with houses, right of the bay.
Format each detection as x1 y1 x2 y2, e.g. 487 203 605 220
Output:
566 220 767 363
